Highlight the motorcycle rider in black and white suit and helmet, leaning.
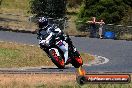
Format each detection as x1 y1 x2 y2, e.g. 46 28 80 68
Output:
38 17 68 63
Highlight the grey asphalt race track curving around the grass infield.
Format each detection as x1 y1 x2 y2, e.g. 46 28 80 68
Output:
0 31 132 73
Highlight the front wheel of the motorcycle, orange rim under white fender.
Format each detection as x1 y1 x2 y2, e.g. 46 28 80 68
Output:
49 48 65 69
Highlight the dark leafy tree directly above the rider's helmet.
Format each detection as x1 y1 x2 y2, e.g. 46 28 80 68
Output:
30 0 66 18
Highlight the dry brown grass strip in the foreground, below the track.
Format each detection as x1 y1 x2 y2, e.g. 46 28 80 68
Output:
0 74 132 88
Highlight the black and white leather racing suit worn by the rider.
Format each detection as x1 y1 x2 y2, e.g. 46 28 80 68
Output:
39 25 68 63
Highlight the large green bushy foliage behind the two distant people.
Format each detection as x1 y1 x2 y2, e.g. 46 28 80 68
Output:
78 0 131 23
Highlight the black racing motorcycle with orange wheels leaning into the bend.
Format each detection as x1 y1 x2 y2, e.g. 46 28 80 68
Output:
37 30 83 69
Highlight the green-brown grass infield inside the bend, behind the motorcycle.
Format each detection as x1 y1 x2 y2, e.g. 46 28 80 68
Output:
0 42 94 68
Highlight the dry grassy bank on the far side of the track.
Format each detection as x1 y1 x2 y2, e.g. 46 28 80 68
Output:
0 0 87 36
